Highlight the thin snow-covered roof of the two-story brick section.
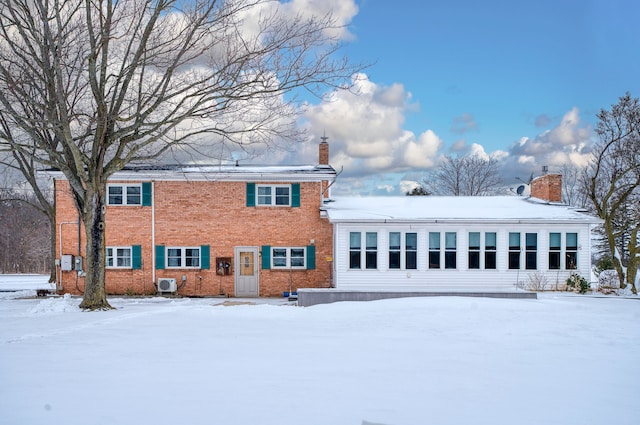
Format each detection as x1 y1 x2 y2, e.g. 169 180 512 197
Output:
43 165 336 182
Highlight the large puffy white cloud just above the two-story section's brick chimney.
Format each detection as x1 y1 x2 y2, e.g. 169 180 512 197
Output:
305 74 443 175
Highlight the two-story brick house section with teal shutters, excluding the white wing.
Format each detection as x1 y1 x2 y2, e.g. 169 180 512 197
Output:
49 143 336 296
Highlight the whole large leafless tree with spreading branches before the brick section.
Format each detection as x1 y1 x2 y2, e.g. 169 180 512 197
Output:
0 0 359 309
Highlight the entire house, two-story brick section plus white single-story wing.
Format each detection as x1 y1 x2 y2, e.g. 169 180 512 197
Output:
51 142 600 297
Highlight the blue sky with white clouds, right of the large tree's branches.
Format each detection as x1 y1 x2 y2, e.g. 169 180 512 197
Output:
268 0 640 194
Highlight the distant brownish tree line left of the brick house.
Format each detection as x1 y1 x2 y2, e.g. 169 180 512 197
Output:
0 189 51 274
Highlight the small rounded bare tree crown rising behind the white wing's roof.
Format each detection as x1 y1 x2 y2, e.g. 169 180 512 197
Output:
423 155 502 196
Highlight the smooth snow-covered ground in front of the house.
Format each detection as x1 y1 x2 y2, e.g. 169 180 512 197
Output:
0 277 640 425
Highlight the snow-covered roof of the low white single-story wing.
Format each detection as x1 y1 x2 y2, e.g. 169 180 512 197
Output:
324 196 600 224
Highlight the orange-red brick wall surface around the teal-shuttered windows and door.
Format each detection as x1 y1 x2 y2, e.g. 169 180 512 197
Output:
56 180 333 296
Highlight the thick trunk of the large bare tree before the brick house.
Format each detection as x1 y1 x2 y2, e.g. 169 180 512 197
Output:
80 185 113 310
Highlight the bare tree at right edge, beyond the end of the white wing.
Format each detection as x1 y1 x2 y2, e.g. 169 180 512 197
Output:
584 93 640 293
